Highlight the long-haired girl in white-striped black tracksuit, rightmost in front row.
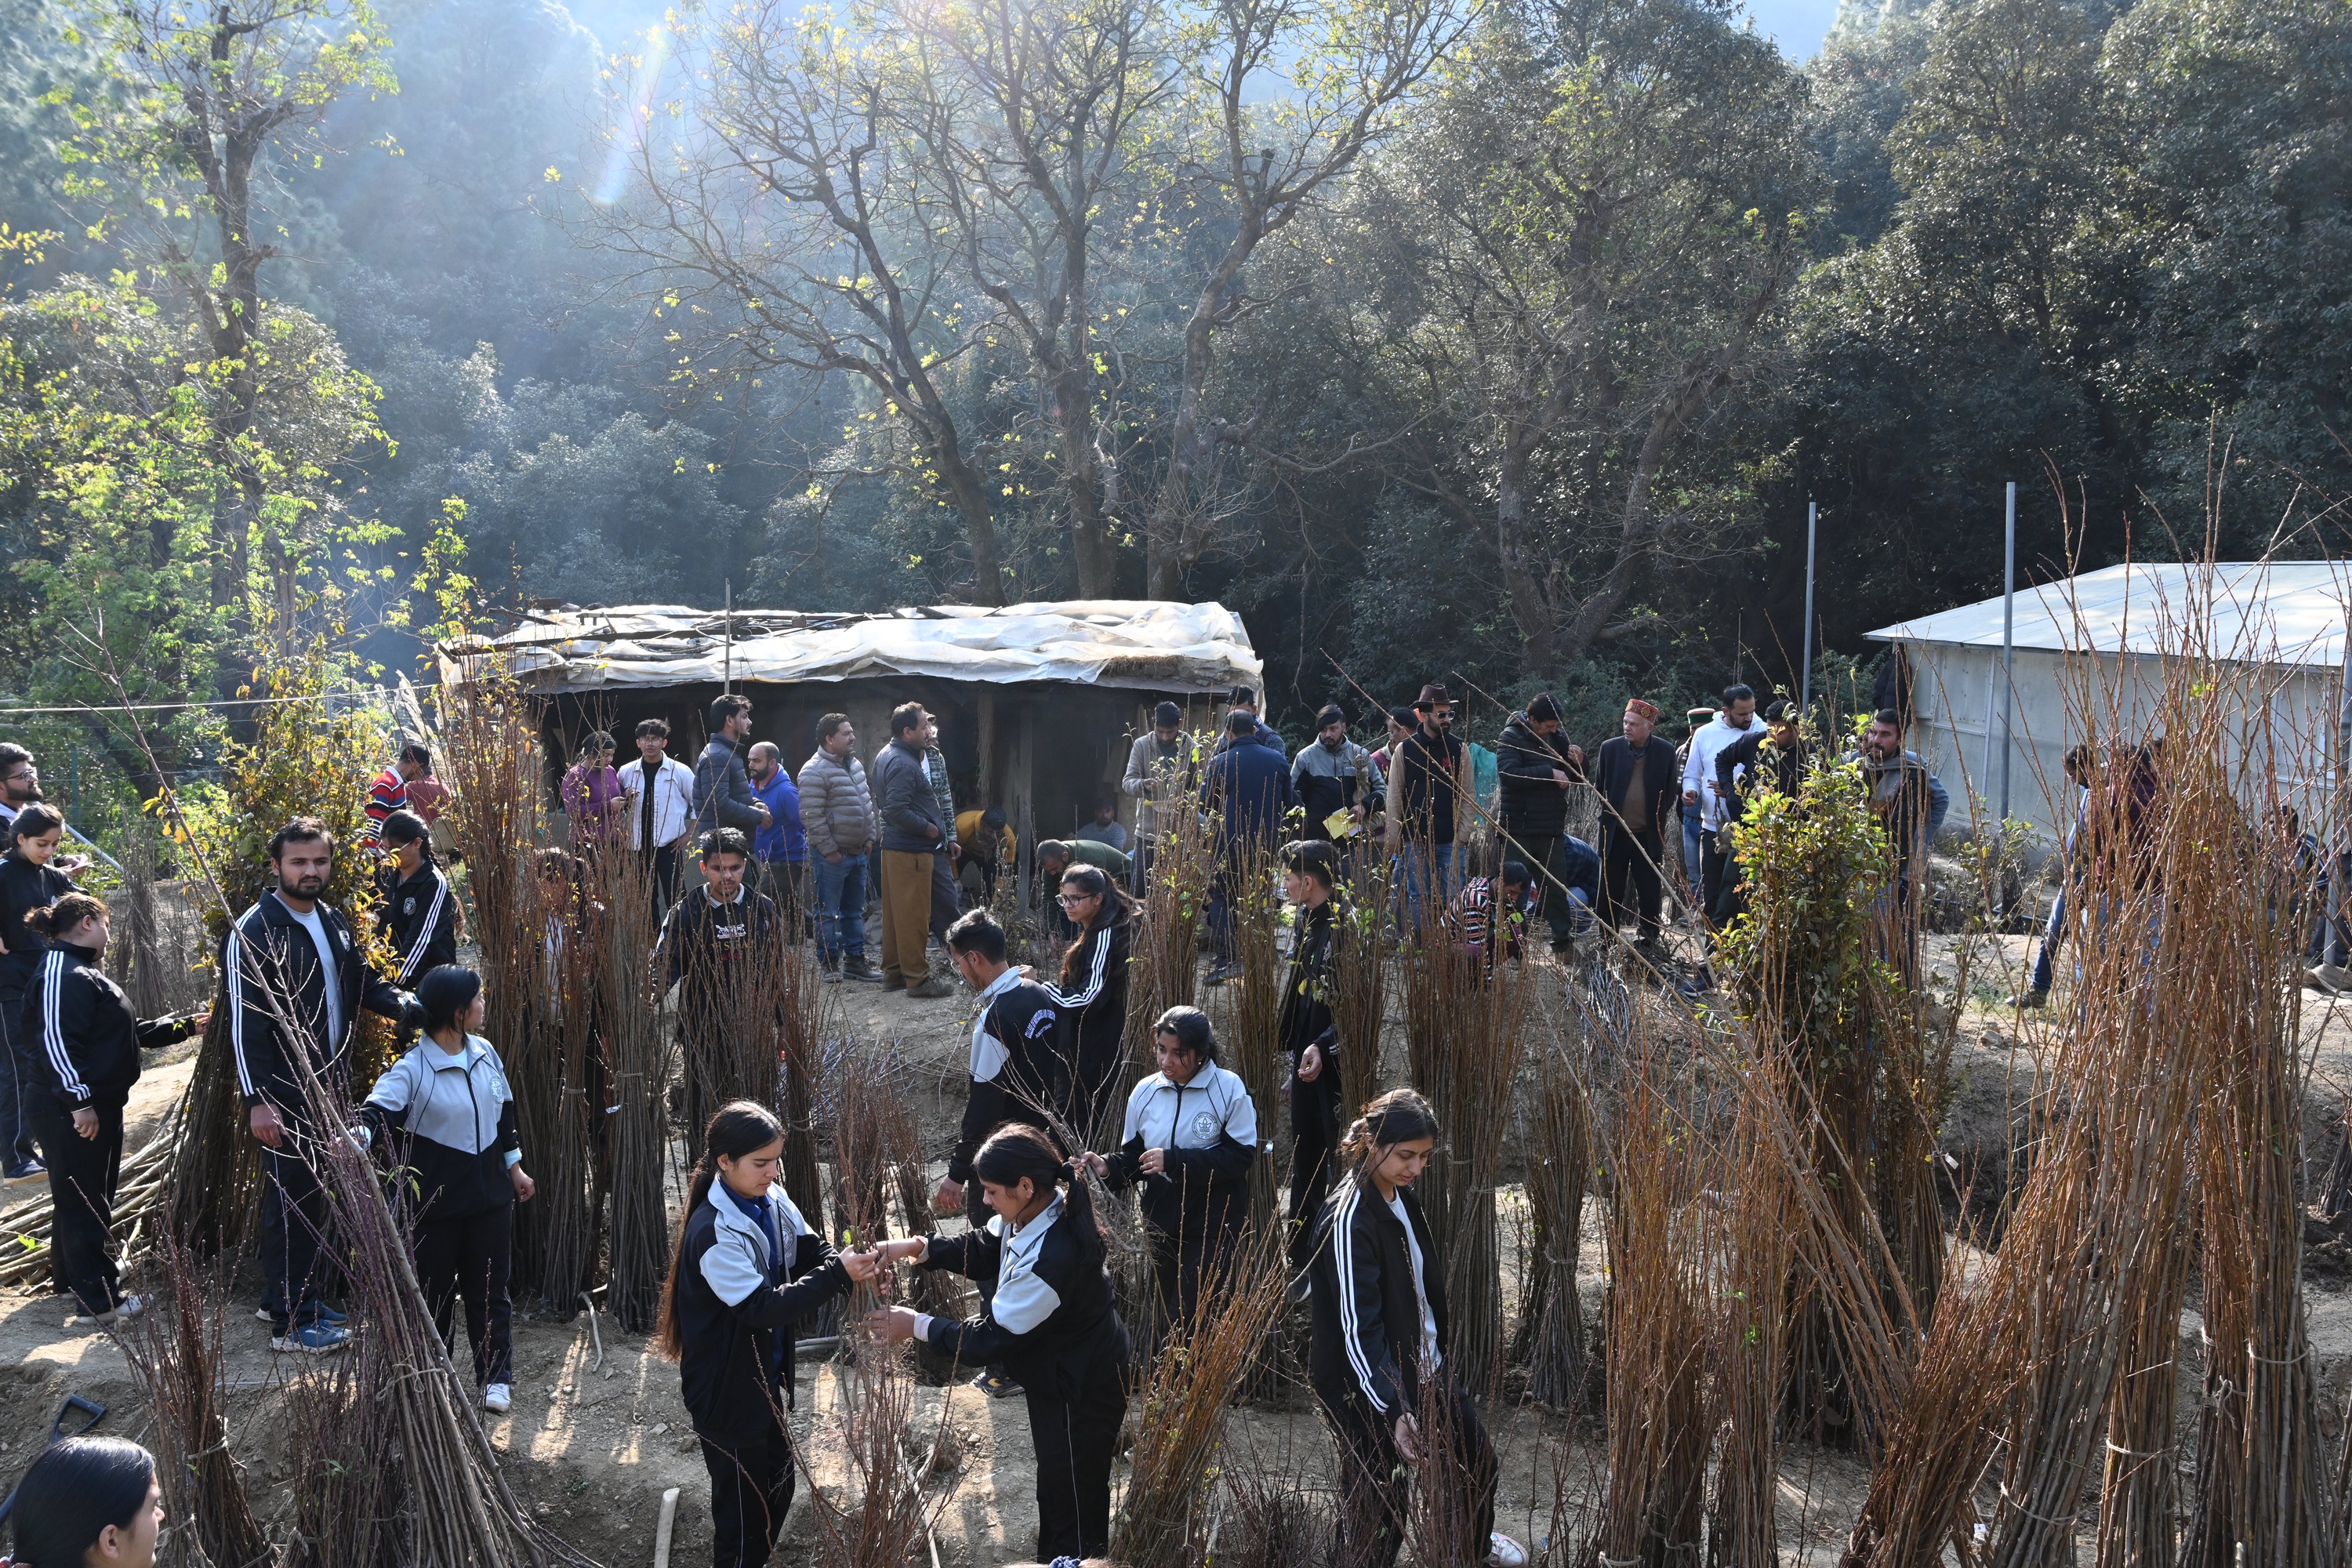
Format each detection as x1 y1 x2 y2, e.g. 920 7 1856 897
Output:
1310 1088 1526 1568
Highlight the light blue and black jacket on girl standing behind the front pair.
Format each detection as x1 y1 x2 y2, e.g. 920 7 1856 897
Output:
1108 1062 1258 1236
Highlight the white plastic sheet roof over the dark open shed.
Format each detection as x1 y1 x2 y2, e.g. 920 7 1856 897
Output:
437 600 1263 691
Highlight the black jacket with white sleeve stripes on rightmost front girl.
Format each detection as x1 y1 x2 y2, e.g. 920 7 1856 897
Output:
1310 1180 1446 1425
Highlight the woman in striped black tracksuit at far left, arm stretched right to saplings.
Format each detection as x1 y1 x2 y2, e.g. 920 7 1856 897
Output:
16 891 207 1323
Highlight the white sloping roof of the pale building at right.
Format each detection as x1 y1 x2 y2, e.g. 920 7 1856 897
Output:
1870 562 2352 668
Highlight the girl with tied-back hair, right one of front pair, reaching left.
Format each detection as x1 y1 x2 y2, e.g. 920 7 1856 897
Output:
868 1126 1129 1559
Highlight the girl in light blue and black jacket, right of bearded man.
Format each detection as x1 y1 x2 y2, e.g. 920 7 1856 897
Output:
353 964 536 1415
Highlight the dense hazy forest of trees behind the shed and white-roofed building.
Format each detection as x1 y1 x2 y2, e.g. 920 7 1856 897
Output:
0 0 2352 808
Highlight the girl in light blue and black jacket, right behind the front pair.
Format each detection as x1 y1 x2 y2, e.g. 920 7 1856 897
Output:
1087 1006 1258 1342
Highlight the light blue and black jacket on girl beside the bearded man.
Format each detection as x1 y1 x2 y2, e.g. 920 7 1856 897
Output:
360 1034 522 1220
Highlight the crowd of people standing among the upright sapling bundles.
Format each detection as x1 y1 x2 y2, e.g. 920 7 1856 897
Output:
0 684 1947 1568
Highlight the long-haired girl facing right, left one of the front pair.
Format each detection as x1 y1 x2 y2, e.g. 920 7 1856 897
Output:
654 1100 877 1568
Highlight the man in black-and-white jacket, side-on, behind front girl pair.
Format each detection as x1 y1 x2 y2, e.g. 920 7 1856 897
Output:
931 909 1075 1399
